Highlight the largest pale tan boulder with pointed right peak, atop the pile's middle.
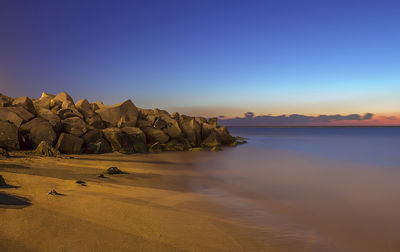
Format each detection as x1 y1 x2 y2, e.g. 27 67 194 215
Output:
96 100 139 128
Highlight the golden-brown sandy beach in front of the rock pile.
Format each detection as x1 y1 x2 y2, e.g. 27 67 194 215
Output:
0 152 282 252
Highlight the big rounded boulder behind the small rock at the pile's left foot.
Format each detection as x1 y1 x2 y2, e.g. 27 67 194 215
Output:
19 117 57 149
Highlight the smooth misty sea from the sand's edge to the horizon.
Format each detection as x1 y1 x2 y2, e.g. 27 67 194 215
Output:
192 128 400 251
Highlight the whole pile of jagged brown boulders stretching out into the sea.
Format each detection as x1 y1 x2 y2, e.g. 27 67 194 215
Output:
0 92 236 156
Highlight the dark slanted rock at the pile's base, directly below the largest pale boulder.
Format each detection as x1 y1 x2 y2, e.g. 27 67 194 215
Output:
103 128 134 154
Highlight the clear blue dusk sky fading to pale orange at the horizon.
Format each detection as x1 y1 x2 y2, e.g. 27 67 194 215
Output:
0 0 400 125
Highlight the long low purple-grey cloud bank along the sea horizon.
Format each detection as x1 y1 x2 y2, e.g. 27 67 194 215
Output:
220 112 374 126
